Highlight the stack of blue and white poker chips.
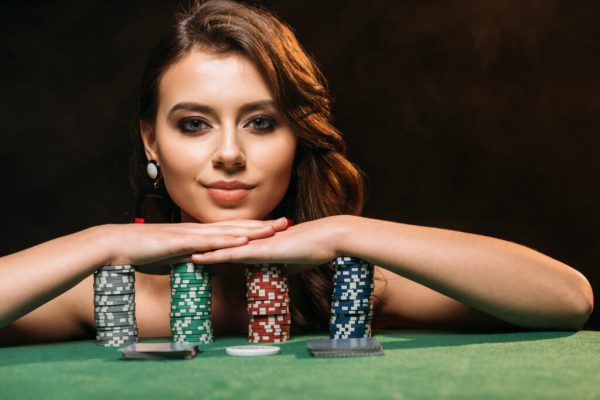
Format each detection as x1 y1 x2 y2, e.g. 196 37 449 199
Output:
329 257 374 339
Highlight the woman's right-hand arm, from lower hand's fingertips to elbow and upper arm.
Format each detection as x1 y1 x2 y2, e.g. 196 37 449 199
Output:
192 216 593 330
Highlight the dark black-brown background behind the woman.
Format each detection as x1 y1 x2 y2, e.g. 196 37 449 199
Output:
0 0 600 328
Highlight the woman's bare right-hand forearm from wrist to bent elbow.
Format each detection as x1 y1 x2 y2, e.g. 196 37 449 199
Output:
338 216 593 329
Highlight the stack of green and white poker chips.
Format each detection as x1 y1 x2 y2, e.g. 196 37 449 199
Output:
170 263 213 343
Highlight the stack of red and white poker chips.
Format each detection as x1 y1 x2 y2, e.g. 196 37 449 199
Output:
246 264 292 343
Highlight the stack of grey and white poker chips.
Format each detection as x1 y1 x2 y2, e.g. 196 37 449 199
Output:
94 265 138 346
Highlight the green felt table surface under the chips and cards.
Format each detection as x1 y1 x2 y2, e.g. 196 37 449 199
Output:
0 331 600 400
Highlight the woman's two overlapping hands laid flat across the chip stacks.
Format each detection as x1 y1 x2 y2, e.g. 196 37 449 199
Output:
109 216 343 274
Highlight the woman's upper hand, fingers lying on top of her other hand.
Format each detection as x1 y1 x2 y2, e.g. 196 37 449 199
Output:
104 218 288 274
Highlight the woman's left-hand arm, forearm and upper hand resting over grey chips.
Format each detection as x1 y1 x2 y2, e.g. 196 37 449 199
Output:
0 219 287 329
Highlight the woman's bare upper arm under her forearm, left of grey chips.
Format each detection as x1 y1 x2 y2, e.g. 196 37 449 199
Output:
0 275 93 345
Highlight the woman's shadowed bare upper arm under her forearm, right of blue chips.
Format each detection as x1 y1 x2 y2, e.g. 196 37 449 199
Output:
373 267 511 329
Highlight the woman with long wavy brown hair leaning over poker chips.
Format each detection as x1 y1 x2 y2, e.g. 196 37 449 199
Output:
0 1 593 343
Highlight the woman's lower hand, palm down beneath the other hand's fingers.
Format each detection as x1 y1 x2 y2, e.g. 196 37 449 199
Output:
191 216 343 269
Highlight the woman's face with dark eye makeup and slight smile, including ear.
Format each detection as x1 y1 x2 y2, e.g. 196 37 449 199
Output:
141 50 296 222
